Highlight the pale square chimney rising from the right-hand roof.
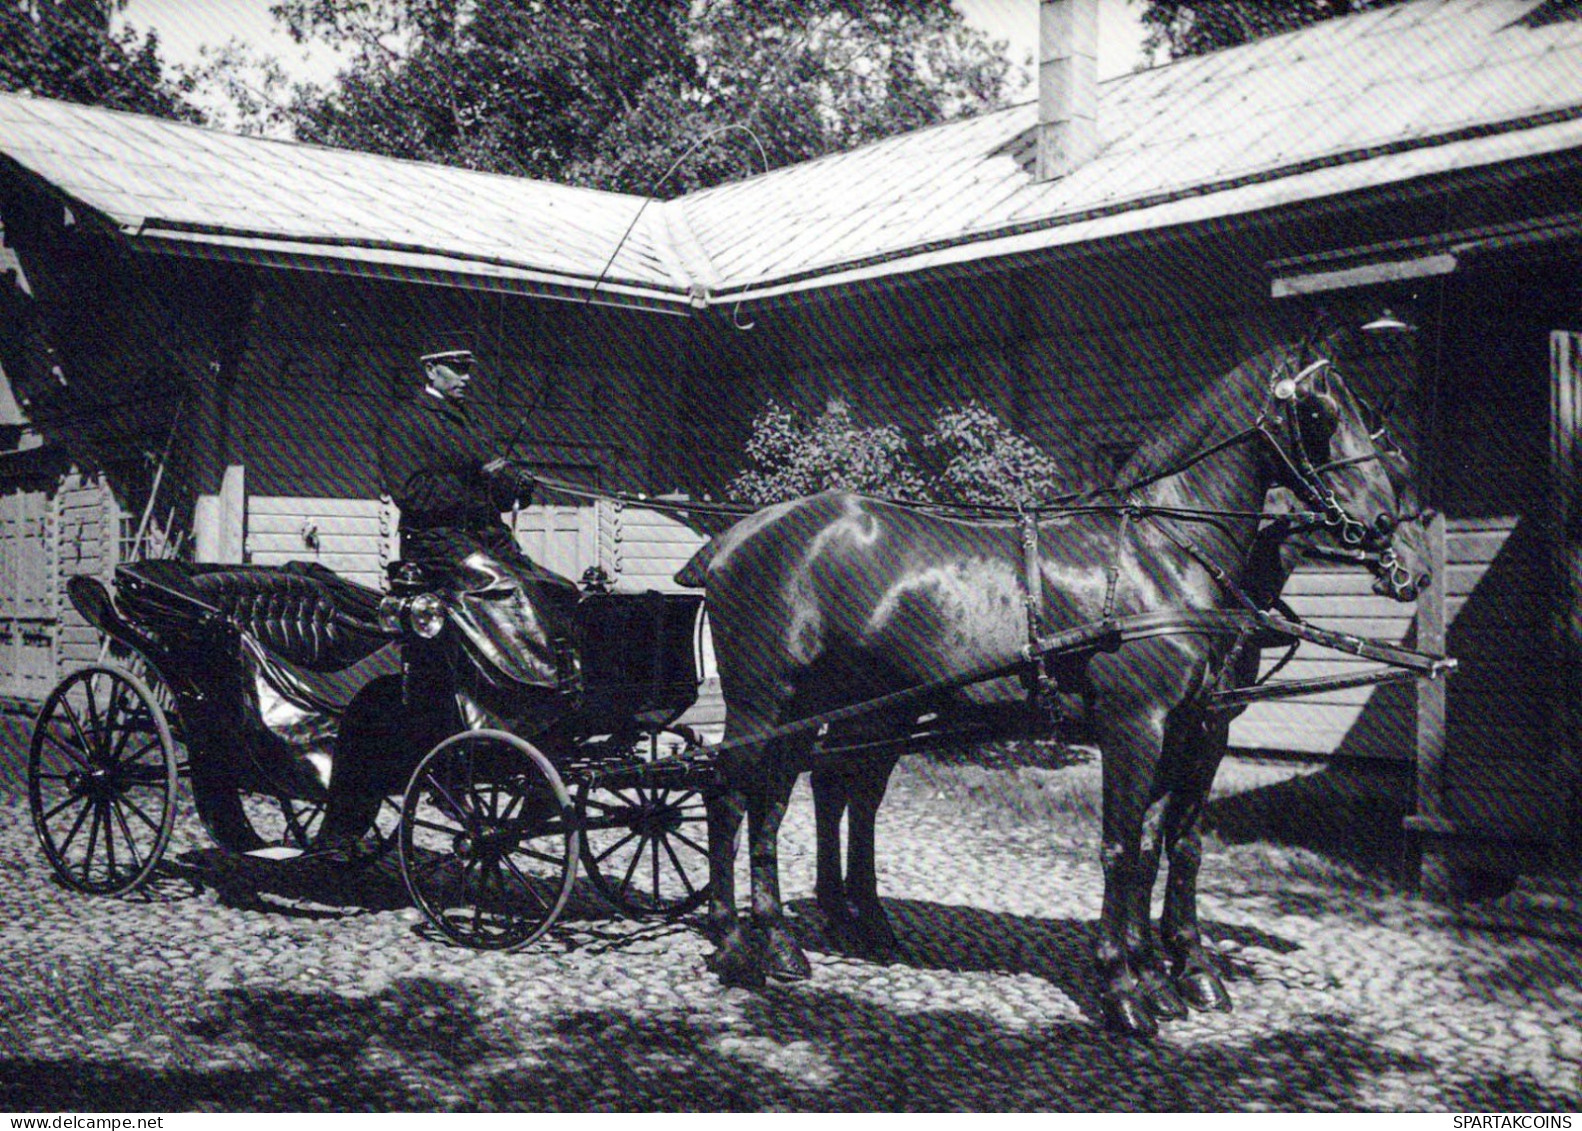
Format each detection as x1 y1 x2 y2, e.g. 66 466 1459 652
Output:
1038 0 1099 182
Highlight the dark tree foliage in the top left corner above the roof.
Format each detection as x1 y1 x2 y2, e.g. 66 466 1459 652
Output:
0 0 202 122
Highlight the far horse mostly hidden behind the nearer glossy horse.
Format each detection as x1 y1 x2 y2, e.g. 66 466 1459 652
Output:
810 442 1435 974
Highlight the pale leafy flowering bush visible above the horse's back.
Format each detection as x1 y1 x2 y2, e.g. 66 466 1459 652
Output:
726 400 1062 506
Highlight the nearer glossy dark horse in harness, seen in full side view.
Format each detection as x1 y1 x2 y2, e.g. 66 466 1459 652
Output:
689 343 1423 1036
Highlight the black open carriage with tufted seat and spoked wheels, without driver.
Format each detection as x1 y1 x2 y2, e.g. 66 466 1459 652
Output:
28 555 707 949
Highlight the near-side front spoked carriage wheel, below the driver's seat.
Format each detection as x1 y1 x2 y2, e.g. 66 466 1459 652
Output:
400 731 581 951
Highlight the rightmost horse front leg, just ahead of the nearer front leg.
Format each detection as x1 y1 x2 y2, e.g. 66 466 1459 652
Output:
1160 718 1231 1012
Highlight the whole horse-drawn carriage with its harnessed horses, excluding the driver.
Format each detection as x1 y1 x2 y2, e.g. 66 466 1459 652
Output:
30 343 1454 1035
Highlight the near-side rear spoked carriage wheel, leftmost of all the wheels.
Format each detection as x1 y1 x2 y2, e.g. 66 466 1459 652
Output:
27 664 180 895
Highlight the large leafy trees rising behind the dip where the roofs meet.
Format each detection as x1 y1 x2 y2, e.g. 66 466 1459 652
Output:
238 0 1011 195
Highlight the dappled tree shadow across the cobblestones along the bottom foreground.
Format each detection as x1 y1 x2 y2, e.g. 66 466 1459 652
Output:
0 979 1569 1112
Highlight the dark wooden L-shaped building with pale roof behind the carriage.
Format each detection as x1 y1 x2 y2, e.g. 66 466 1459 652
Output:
0 0 1582 892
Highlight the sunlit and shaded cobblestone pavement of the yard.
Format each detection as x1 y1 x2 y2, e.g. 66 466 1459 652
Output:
0 759 1582 1110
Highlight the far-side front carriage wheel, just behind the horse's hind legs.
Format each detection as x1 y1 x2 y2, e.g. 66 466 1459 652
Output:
577 728 709 917
